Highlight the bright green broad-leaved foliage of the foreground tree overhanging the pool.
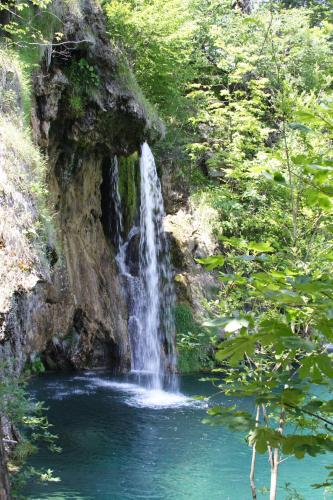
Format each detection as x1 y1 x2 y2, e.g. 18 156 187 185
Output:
197 98 333 498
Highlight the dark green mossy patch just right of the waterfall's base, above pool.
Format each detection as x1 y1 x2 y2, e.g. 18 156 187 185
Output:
175 304 214 373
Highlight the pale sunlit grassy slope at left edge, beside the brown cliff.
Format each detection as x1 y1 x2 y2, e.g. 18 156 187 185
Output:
0 48 55 299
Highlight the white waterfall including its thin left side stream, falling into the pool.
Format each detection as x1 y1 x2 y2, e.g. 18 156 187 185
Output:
111 143 176 391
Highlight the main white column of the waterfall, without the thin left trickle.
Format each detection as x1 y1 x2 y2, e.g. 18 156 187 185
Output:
134 143 174 386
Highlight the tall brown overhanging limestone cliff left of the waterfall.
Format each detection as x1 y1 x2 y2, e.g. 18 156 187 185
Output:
0 0 161 371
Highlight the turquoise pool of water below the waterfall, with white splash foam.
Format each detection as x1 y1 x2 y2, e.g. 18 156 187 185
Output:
25 372 333 500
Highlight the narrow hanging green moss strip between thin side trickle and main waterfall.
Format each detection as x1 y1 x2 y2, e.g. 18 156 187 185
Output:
119 153 140 234
